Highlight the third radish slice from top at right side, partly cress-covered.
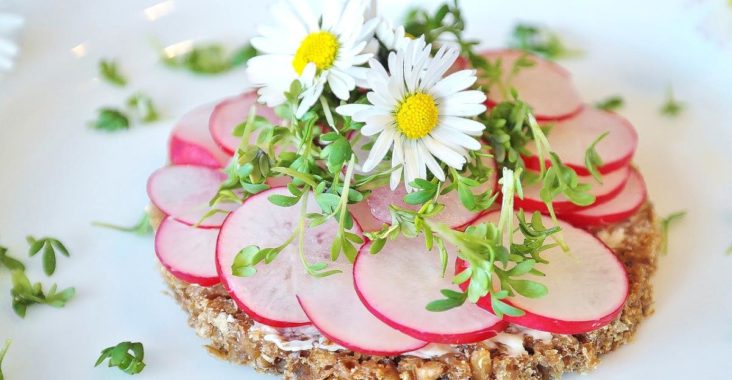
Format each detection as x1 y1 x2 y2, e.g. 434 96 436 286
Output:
515 166 631 213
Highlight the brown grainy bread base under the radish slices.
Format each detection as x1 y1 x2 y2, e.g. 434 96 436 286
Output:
157 204 660 380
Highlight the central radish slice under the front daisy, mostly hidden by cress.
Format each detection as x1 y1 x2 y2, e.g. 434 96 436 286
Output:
367 159 498 228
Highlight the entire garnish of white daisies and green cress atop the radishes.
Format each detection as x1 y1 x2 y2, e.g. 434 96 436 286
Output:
207 0 601 317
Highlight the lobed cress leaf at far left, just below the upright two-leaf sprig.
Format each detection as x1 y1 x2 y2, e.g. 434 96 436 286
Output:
10 270 76 318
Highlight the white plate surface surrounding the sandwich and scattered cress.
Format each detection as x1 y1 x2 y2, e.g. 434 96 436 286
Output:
0 0 732 379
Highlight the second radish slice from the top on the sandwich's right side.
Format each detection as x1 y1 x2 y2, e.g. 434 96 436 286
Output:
524 107 638 175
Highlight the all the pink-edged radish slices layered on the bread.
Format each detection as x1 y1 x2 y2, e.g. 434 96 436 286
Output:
148 50 646 355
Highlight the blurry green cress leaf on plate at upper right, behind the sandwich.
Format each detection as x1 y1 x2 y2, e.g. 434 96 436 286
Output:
508 24 579 60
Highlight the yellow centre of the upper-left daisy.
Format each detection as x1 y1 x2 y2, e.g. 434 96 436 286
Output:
292 31 340 75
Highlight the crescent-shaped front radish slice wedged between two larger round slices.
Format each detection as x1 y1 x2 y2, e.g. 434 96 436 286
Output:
296 250 427 356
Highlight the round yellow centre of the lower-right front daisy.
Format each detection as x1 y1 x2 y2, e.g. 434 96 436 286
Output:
396 92 440 139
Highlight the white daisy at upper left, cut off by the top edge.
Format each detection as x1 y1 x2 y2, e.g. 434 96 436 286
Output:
247 0 378 117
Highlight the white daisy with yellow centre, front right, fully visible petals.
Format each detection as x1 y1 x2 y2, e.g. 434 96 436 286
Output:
337 38 486 191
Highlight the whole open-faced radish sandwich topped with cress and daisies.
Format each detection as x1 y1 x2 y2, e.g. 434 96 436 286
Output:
148 0 659 379
